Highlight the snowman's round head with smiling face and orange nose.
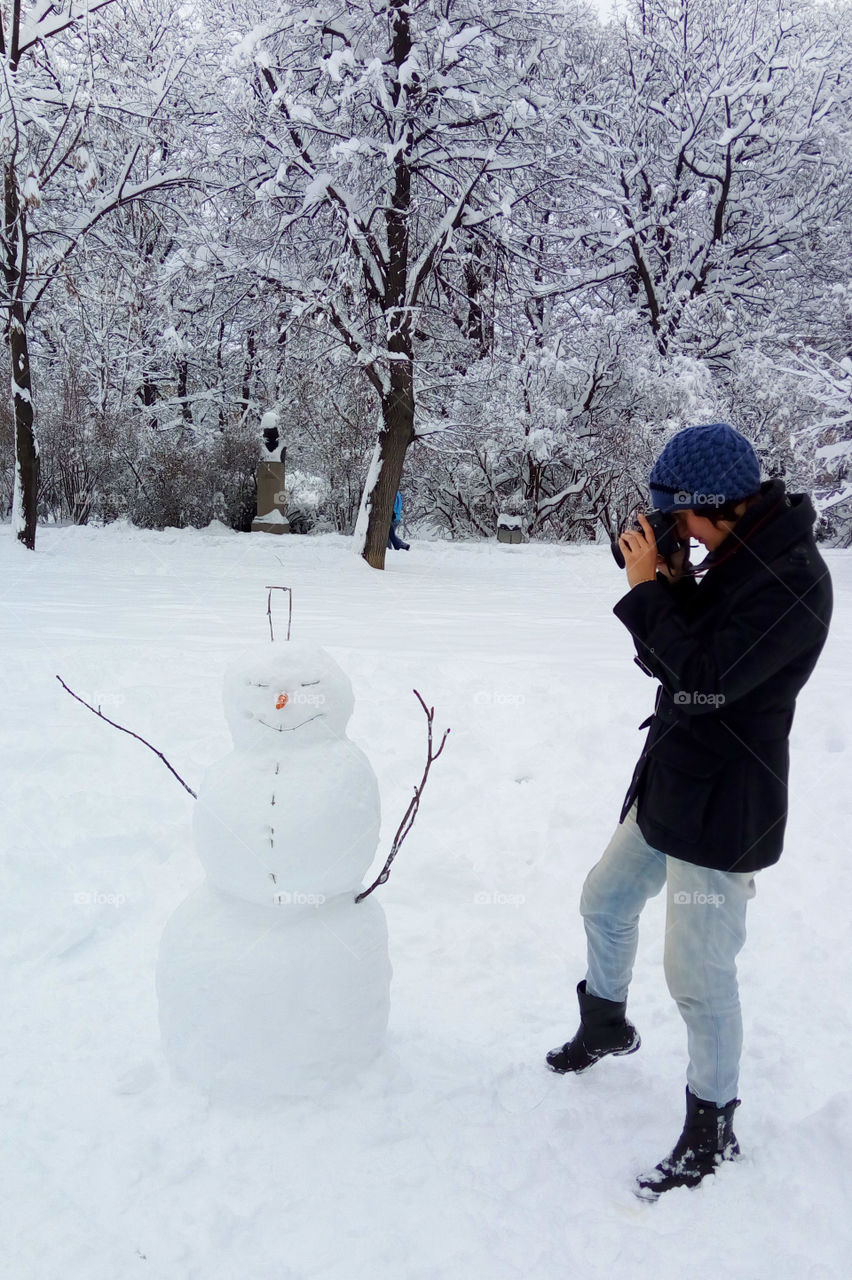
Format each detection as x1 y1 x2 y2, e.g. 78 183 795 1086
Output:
224 640 354 751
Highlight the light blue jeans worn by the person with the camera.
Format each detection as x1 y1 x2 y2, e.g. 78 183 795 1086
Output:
580 804 755 1106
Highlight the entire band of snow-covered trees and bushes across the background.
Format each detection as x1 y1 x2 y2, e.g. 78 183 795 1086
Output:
0 0 852 545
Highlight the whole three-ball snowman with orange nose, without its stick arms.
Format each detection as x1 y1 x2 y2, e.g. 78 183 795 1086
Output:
156 641 391 1101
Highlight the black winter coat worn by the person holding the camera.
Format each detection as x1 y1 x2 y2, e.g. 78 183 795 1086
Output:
613 480 833 872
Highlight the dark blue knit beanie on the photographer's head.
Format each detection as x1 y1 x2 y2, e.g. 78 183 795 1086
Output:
651 422 760 511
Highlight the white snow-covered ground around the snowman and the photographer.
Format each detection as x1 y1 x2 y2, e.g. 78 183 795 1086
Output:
0 525 852 1280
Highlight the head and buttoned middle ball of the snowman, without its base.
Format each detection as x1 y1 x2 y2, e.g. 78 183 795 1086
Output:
193 641 381 905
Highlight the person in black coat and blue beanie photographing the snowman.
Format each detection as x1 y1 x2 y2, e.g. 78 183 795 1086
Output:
546 424 833 1199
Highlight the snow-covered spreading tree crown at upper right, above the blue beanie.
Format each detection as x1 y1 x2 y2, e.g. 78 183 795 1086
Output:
555 0 851 366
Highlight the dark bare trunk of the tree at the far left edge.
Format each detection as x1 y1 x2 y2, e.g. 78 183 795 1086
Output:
3 164 38 550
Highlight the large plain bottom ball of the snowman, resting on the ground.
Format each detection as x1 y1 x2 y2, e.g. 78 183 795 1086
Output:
156 882 391 1103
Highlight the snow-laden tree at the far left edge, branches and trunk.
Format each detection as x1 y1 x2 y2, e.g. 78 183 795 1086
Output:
0 0 188 549
